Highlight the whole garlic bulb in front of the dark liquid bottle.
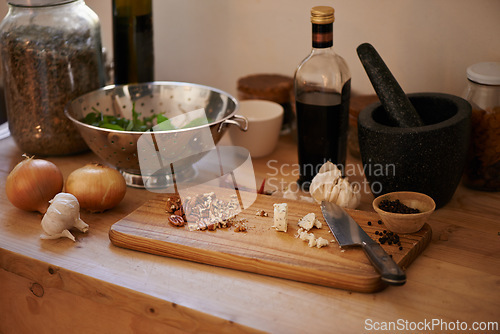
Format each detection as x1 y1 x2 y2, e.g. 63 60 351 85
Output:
309 161 361 209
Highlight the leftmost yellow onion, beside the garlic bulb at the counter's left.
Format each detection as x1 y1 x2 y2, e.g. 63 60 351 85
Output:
5 155 64 213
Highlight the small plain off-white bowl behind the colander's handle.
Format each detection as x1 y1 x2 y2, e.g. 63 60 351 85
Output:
229 100 283 158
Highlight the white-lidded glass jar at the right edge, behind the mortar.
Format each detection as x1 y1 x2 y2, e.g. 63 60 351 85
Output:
463 62 500 191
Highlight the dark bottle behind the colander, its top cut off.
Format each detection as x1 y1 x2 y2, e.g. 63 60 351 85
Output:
113 0 154 84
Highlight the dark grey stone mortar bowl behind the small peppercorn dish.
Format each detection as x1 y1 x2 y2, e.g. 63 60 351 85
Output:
358 93 471 208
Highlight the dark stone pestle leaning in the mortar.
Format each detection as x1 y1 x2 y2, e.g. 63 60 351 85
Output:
356 43 425 128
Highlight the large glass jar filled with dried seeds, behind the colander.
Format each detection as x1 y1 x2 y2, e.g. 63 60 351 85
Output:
0 0 105 156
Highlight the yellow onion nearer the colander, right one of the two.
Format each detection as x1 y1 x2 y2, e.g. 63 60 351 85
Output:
65 163 127 212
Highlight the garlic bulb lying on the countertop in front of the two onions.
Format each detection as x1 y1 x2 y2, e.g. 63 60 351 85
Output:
40 193 89 241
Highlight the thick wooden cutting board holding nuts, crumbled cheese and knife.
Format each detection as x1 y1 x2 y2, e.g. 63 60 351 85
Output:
109 195 432 292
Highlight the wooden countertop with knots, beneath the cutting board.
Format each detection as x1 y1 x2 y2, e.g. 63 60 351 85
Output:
0 132 500 333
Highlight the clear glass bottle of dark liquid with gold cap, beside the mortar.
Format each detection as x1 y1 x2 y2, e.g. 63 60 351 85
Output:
294 6 351 190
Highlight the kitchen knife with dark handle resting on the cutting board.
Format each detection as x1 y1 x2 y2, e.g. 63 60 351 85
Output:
321 201 406 285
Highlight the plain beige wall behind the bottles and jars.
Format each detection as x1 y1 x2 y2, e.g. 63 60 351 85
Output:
0 0 500 95
